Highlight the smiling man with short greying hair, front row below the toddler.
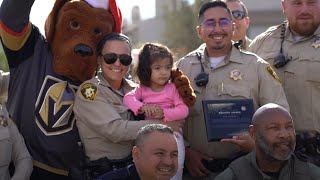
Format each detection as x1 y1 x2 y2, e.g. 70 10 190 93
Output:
101 124 178 180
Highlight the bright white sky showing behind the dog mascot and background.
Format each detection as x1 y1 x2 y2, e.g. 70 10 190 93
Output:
0 0 194 33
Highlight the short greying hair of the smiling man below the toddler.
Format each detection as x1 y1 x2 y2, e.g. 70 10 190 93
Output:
135 124 174 148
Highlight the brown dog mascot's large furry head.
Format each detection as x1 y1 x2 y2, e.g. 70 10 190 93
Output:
45 0 122 82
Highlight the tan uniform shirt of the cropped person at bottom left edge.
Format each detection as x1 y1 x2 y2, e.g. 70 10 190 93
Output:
0 119 33 180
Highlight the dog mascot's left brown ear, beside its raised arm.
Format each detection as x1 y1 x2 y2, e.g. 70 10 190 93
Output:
44 0 69 43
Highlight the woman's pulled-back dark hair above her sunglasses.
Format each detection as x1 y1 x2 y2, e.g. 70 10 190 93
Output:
97 32 132 56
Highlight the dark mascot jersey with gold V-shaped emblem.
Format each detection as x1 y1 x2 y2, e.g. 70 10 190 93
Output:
0 0 79 175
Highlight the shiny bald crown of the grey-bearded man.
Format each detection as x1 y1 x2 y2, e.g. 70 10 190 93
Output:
252 103 292 126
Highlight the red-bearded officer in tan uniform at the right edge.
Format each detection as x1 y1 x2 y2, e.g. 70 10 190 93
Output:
249 0 320 166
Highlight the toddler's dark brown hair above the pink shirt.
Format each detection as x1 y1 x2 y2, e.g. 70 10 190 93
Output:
134 43 173 87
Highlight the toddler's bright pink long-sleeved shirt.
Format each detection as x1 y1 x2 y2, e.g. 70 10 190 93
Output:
123 83 189 121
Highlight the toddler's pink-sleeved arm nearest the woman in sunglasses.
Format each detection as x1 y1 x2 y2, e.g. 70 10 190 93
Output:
123 86 143 115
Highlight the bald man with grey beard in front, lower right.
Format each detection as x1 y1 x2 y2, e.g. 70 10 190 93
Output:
216 103 320 180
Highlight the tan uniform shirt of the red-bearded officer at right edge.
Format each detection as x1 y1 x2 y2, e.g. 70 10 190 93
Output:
249 23 320 132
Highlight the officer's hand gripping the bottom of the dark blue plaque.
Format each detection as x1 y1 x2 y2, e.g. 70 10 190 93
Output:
221 135 255 153
